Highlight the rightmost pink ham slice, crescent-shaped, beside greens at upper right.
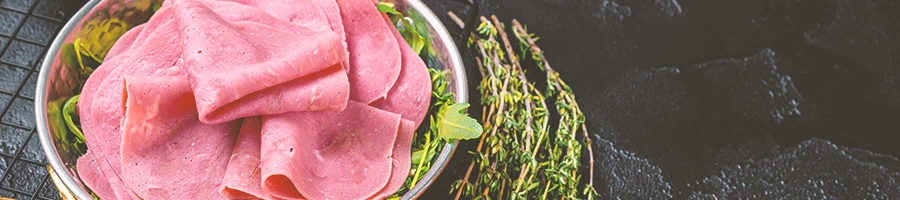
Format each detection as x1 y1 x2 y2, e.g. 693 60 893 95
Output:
372 13 432 127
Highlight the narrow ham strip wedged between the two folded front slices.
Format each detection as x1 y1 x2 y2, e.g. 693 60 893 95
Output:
219 117 268 199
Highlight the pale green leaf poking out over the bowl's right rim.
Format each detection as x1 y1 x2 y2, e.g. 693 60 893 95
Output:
438 103 483 140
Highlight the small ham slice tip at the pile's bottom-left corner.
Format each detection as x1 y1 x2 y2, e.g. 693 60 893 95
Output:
77 150 116 199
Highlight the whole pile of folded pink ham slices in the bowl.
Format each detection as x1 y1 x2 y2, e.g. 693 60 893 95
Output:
77 0 431 199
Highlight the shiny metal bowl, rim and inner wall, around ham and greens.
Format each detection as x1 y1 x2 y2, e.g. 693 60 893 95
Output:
35 0 471 199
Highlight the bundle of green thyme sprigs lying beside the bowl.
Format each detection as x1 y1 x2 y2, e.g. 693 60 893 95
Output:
450 13 597 199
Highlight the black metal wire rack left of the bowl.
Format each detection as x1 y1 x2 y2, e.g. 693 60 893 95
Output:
0 0 84 199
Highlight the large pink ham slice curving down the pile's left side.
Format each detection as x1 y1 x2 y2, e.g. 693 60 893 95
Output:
78 6 183 199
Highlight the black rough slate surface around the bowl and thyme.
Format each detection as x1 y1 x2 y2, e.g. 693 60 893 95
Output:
0 0 900 199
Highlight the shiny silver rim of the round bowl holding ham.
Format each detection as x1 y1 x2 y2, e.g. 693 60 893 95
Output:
34 0 468 199
